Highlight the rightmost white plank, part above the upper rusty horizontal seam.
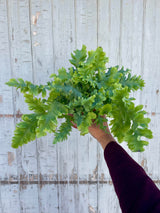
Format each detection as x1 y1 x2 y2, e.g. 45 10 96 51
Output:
141 0 160 113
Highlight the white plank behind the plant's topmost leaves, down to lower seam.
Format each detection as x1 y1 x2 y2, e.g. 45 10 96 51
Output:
76 1 97 180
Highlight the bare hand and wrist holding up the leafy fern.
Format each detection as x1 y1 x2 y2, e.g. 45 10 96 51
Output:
69 114 116 149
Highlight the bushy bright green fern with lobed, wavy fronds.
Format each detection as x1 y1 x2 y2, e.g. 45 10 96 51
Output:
6 45 153 152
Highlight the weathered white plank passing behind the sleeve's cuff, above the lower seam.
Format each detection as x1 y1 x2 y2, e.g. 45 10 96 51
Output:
97 0 120 183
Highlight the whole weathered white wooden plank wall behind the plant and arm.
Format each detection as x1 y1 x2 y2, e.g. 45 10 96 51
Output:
0 0 160 213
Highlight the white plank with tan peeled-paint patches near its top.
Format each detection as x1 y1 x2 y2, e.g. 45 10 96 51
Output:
30 0 58 212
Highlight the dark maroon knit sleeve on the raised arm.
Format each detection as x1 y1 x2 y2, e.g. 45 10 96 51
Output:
104 142 160 213
